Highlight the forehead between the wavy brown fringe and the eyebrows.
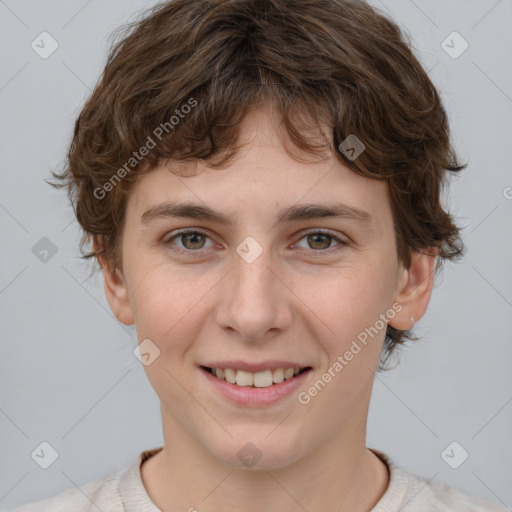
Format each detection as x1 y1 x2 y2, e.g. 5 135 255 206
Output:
127 105 390 226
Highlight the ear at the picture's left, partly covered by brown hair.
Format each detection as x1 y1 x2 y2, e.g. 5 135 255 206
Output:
93 238 134 325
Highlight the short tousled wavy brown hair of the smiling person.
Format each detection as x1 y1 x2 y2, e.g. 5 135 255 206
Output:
54 0 465 366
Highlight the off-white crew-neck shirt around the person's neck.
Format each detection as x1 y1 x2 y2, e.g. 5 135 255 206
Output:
12 447 508 512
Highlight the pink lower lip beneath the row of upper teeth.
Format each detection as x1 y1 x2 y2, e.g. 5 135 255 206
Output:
199 368 311 406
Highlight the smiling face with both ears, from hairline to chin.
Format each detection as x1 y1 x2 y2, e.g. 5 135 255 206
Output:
104 106 432 468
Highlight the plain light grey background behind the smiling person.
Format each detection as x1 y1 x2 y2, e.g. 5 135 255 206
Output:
0 0 512 510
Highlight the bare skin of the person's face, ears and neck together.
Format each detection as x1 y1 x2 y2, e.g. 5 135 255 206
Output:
95 108 435 512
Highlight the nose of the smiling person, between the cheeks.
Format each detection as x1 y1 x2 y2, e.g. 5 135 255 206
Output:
216 244 293 342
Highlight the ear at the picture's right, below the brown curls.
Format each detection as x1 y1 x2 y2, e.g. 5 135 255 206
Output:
389 249 437 331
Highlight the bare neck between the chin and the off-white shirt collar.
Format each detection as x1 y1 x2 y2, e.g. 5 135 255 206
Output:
141 412 389 512
